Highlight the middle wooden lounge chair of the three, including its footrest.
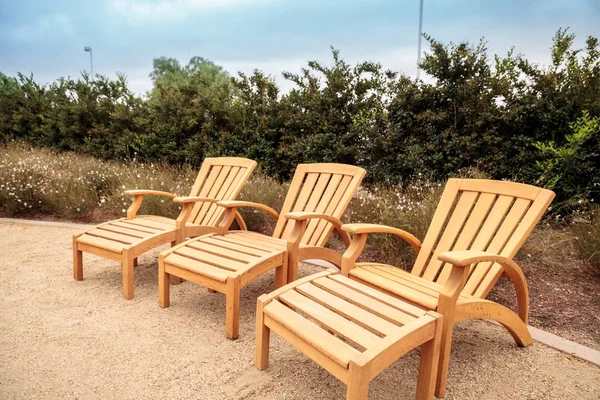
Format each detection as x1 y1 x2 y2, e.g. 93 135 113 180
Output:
158 164 365 339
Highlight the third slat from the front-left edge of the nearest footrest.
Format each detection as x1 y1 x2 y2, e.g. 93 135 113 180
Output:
296 283 398 336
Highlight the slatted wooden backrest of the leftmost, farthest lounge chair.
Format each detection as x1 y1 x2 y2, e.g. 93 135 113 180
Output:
189 157 256 226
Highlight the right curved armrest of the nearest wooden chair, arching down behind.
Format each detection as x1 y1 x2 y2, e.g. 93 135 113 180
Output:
438 250 529 323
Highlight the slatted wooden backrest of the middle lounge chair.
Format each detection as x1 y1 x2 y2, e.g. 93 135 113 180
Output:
273 163 366 247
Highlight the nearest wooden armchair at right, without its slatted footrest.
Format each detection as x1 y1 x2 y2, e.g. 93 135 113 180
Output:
342 179 554 397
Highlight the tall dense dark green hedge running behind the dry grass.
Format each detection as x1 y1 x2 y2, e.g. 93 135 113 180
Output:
0 30 600 208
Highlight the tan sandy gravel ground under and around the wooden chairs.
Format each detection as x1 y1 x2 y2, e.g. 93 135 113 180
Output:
0 223 600 399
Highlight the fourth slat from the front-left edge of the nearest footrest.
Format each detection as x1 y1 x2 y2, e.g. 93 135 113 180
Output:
313 278 415 325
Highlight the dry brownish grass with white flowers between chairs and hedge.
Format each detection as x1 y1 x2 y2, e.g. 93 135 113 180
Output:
0 143 600 267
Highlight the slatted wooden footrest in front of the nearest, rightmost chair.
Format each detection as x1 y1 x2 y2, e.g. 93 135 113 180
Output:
255 271 442 399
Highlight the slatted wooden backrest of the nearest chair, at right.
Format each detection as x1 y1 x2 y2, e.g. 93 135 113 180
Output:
412 179 554 298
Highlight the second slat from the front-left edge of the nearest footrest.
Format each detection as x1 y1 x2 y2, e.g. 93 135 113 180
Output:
279 290 381 350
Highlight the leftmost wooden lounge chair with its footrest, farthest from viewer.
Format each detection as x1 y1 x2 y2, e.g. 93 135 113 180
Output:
73 157 256 299
